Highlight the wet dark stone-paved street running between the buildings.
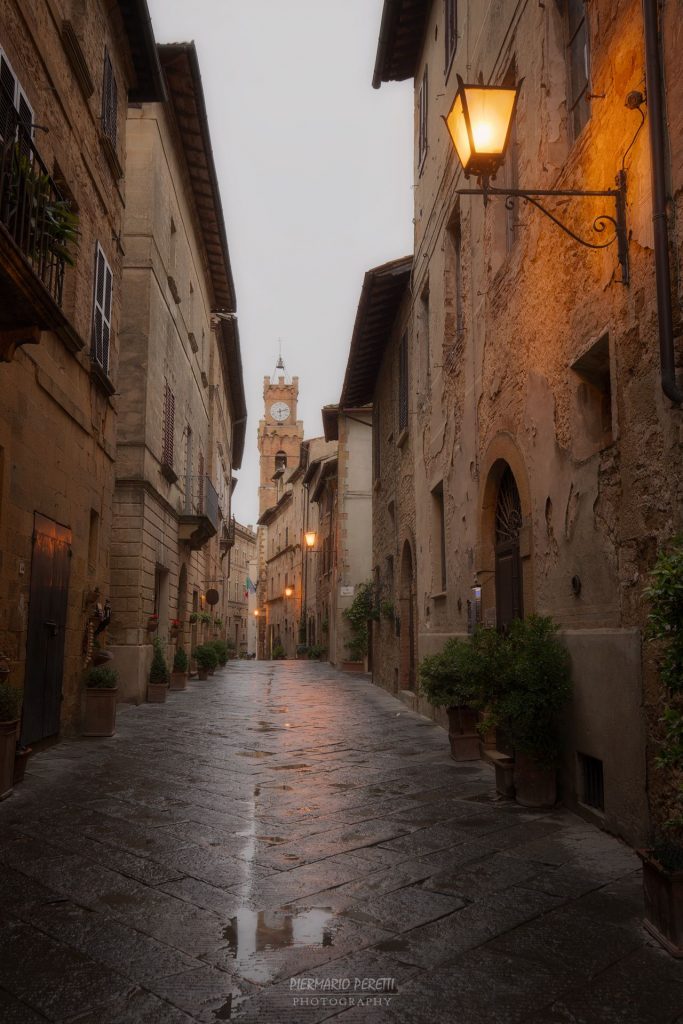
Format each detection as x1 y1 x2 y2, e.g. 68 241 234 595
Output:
0 662 683 1024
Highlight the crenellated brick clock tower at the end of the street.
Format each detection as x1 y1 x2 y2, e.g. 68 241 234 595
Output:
258 355 303 516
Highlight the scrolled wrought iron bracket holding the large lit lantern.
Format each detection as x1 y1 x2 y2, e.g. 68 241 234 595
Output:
457 170 629 285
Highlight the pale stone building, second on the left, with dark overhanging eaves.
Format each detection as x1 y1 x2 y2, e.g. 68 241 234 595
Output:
111 44 246 701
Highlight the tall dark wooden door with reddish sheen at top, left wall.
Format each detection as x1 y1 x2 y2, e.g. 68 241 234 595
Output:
22 513 72 744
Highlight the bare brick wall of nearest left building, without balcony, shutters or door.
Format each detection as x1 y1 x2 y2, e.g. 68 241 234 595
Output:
0 0 148 735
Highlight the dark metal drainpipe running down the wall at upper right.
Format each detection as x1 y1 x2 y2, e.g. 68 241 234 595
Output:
643 0 683 406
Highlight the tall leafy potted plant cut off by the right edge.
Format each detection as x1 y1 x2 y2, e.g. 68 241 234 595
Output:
639 538 683 957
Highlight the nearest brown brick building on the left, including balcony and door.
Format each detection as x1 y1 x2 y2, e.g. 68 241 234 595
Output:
0 0 164 744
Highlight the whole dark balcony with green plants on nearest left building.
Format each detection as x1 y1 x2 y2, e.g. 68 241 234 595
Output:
0 102 82 360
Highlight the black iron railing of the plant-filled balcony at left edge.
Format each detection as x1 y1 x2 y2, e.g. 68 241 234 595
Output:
0 99 68 305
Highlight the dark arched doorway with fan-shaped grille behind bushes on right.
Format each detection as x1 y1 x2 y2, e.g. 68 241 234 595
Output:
496 463 524 630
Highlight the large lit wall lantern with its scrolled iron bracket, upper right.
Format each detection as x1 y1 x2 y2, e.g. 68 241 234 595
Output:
443 75 634 285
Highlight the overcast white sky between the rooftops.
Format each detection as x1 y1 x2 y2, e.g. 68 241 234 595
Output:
148 0 413 523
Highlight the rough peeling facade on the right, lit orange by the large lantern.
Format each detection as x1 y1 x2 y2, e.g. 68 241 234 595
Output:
374 0 683 842
